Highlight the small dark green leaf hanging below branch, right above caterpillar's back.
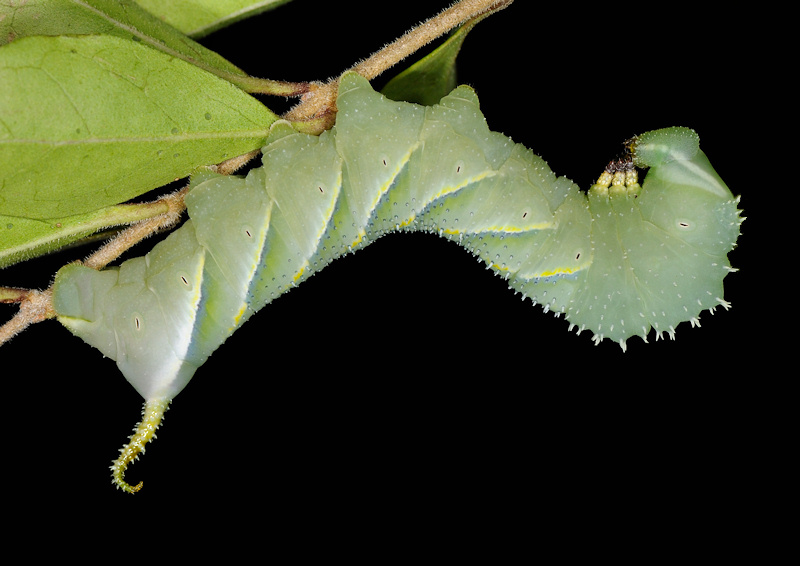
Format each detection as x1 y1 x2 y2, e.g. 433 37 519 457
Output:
381 14 488 106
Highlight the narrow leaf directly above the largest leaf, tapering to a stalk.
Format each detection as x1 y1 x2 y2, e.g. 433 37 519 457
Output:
0 0 247 82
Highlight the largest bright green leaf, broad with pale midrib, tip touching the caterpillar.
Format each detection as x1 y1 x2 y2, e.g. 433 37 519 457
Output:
0 32 277 219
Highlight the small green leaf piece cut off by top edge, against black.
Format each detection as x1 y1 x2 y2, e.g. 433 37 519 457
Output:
137 0 289 37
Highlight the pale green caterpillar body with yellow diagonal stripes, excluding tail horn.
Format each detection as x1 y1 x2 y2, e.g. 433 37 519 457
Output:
53 74 740 400
